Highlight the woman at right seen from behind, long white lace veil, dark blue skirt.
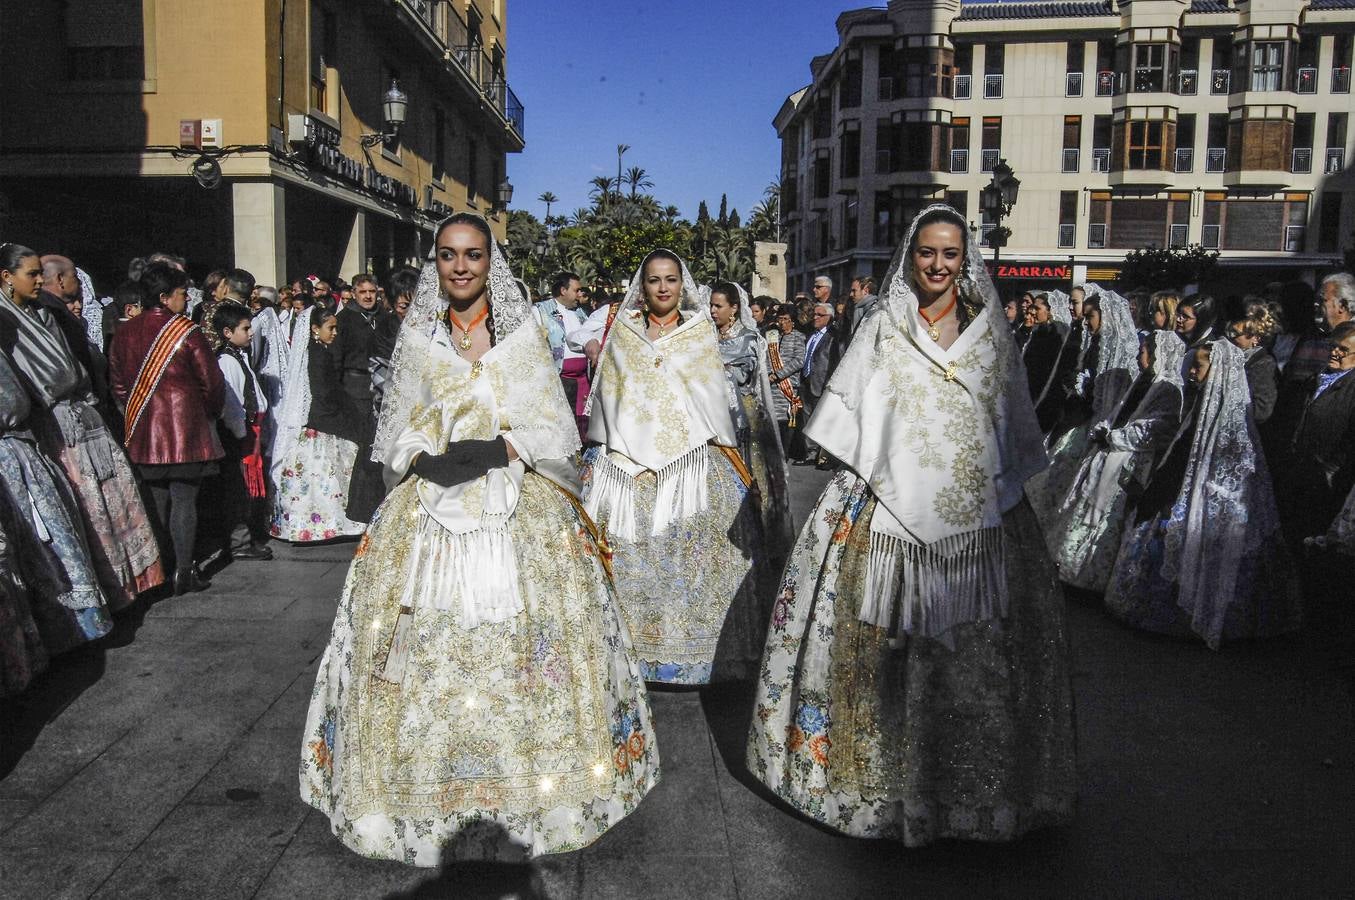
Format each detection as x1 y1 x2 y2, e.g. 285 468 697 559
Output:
1106 338 1301 649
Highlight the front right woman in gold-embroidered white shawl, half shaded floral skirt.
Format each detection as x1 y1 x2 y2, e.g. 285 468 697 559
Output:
748 206 1076 846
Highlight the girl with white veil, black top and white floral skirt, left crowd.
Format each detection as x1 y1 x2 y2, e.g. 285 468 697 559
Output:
270 306 371 544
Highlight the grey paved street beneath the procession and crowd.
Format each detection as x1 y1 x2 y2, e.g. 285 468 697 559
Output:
0 469 1355 900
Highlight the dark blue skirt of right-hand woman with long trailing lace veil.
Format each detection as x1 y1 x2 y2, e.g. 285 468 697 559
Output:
1106 502 1302 649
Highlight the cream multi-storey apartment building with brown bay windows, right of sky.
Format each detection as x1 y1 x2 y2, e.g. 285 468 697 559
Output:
774 0 1355 290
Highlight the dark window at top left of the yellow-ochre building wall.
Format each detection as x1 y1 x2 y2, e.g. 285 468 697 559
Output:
64 0 146 81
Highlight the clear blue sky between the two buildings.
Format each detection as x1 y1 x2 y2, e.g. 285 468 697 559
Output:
507 0 871 218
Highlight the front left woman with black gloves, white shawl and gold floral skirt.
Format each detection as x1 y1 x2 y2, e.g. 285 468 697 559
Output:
301 213 659 866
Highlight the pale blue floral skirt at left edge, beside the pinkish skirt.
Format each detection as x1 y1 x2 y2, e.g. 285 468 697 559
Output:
0 438 112 655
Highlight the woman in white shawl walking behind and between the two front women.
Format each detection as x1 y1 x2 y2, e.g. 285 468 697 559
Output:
583 249 776 684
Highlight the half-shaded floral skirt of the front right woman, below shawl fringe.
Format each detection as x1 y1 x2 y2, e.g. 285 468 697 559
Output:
748 472 1077 846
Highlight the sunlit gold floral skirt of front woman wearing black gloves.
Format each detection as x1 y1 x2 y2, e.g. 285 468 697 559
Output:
301 473 659 866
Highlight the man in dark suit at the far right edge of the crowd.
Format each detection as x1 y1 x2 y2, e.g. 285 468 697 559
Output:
1290 323 1355 538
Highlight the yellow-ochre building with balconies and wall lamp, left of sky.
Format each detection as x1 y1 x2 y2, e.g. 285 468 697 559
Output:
0 0 524 286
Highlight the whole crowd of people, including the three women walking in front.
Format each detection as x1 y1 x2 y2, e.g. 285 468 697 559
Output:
0 206 1355 865
